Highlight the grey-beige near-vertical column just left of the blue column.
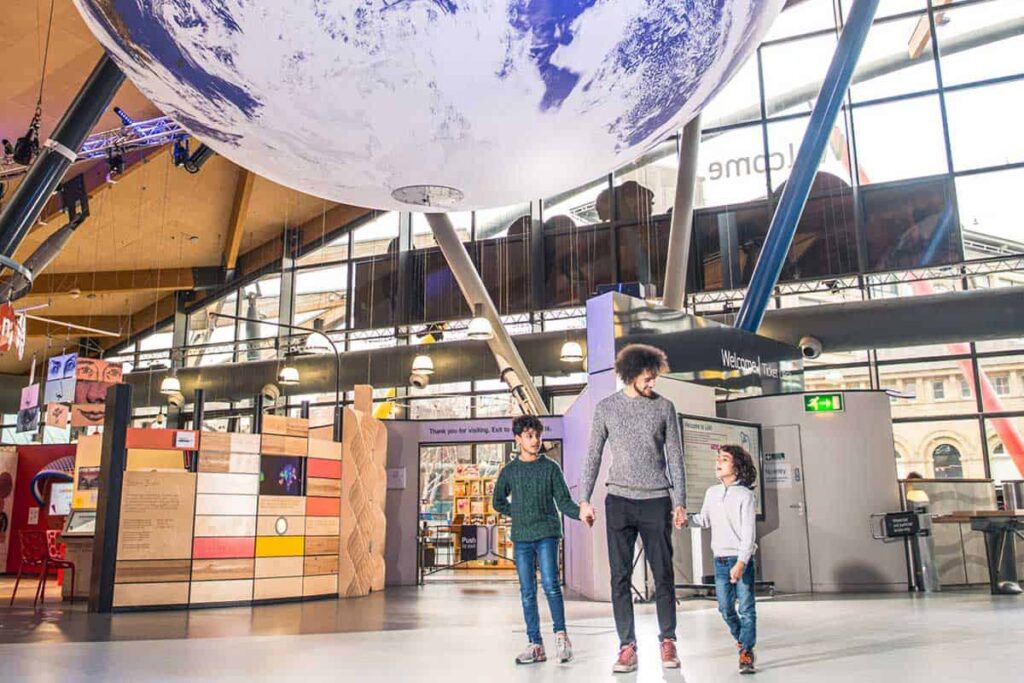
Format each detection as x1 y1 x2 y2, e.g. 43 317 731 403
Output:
662 114 700 310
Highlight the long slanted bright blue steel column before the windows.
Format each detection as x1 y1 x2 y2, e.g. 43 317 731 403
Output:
734 0 879 332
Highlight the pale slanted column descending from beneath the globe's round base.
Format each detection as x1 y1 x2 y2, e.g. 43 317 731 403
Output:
426 213 548 415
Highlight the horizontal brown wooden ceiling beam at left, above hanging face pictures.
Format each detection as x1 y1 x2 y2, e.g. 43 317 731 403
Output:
31 268 199 296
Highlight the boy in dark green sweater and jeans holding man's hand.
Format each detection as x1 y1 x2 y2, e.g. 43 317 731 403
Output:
493 415 580 664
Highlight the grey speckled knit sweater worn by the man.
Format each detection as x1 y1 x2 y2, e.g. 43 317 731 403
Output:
581 391 686 506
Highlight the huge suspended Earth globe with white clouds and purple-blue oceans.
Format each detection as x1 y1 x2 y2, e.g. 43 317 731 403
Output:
75 0 784 210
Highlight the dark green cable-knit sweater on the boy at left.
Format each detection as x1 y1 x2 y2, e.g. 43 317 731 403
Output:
492 455 580 543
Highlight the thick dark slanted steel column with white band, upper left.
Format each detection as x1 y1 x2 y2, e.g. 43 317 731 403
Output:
0 52 125 256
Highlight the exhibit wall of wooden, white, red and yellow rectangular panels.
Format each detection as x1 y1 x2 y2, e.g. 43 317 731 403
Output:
107 416 346 609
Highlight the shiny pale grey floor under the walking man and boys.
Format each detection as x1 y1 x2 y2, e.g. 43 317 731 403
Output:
0 585 1024 683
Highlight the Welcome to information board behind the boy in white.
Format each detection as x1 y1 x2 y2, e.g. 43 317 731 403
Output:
679 415 764 520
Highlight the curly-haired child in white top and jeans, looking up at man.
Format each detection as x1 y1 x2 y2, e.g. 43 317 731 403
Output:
687 445 758 674
